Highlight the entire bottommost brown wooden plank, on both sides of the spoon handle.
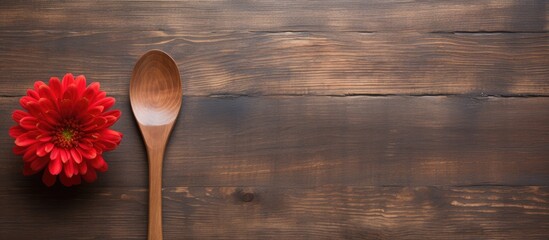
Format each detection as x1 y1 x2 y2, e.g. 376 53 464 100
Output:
0 186 549 239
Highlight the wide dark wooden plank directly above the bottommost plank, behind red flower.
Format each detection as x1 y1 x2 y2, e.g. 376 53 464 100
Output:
0 97 549 187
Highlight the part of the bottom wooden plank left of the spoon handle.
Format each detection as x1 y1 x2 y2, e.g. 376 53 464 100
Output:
0 186 148 240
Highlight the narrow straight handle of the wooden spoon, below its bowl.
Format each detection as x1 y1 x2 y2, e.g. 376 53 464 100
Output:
147 147 164 240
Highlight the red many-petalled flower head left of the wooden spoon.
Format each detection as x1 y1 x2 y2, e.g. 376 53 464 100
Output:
9 73 122 186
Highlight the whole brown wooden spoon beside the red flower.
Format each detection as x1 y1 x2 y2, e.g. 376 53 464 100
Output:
130 50 183 240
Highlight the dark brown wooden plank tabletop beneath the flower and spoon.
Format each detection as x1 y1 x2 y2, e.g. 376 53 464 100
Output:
0 0 549 240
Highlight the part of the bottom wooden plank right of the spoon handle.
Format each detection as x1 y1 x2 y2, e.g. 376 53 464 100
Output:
165 187 549 239
